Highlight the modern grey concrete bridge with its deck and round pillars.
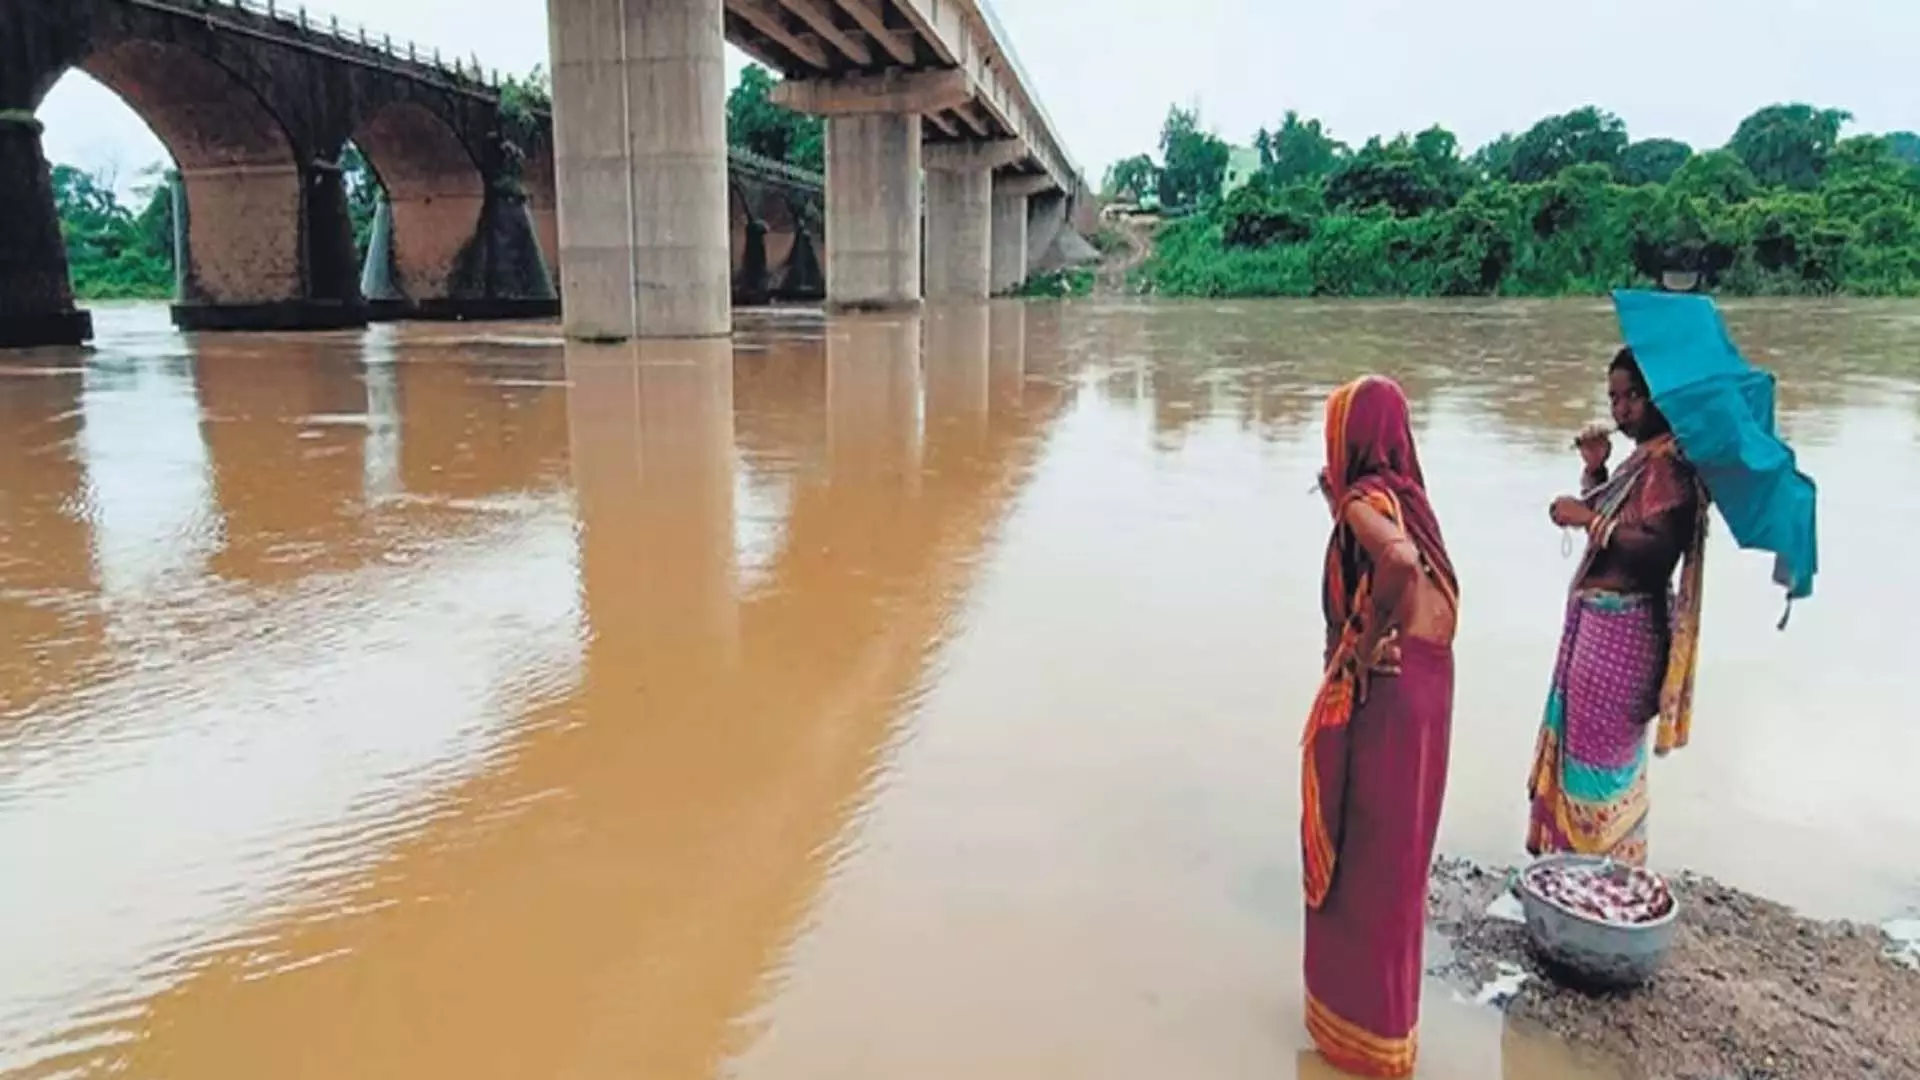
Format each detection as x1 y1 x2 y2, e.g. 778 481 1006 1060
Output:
547 0 1091 340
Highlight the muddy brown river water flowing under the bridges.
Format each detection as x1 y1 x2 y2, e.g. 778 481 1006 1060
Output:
0 302 1920 1080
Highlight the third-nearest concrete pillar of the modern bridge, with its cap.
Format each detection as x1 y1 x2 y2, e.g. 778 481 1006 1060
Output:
922 138 1025 300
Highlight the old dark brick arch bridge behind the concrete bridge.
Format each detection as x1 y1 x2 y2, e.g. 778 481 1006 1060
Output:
0 0 824 346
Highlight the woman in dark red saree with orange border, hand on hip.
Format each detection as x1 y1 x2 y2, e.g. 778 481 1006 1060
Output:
1300 377 1459 1076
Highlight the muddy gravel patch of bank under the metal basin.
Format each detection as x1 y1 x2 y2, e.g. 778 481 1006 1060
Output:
1427 859 1920 1080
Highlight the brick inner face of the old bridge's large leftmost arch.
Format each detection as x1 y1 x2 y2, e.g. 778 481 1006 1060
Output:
77 40 305 304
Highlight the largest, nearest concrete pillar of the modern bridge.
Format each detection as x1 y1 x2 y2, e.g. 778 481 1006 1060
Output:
547 0 733 340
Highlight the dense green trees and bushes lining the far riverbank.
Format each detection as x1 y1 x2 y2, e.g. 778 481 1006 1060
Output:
1104 104 1920 296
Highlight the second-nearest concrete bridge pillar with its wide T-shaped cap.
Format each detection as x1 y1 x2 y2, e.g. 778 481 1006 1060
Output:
772 69 972 311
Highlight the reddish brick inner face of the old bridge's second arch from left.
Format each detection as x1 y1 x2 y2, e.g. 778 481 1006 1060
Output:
351 102 486 302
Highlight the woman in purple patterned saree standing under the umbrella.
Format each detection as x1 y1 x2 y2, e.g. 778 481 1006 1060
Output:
1526 350 1707 863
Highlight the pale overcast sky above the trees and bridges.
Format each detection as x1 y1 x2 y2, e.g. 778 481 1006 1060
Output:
40 0 1920 186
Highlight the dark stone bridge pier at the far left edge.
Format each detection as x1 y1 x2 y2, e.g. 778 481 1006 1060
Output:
0 113 94 348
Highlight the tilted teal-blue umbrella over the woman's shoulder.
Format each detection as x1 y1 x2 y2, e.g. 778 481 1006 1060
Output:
1613 290 1820 611
